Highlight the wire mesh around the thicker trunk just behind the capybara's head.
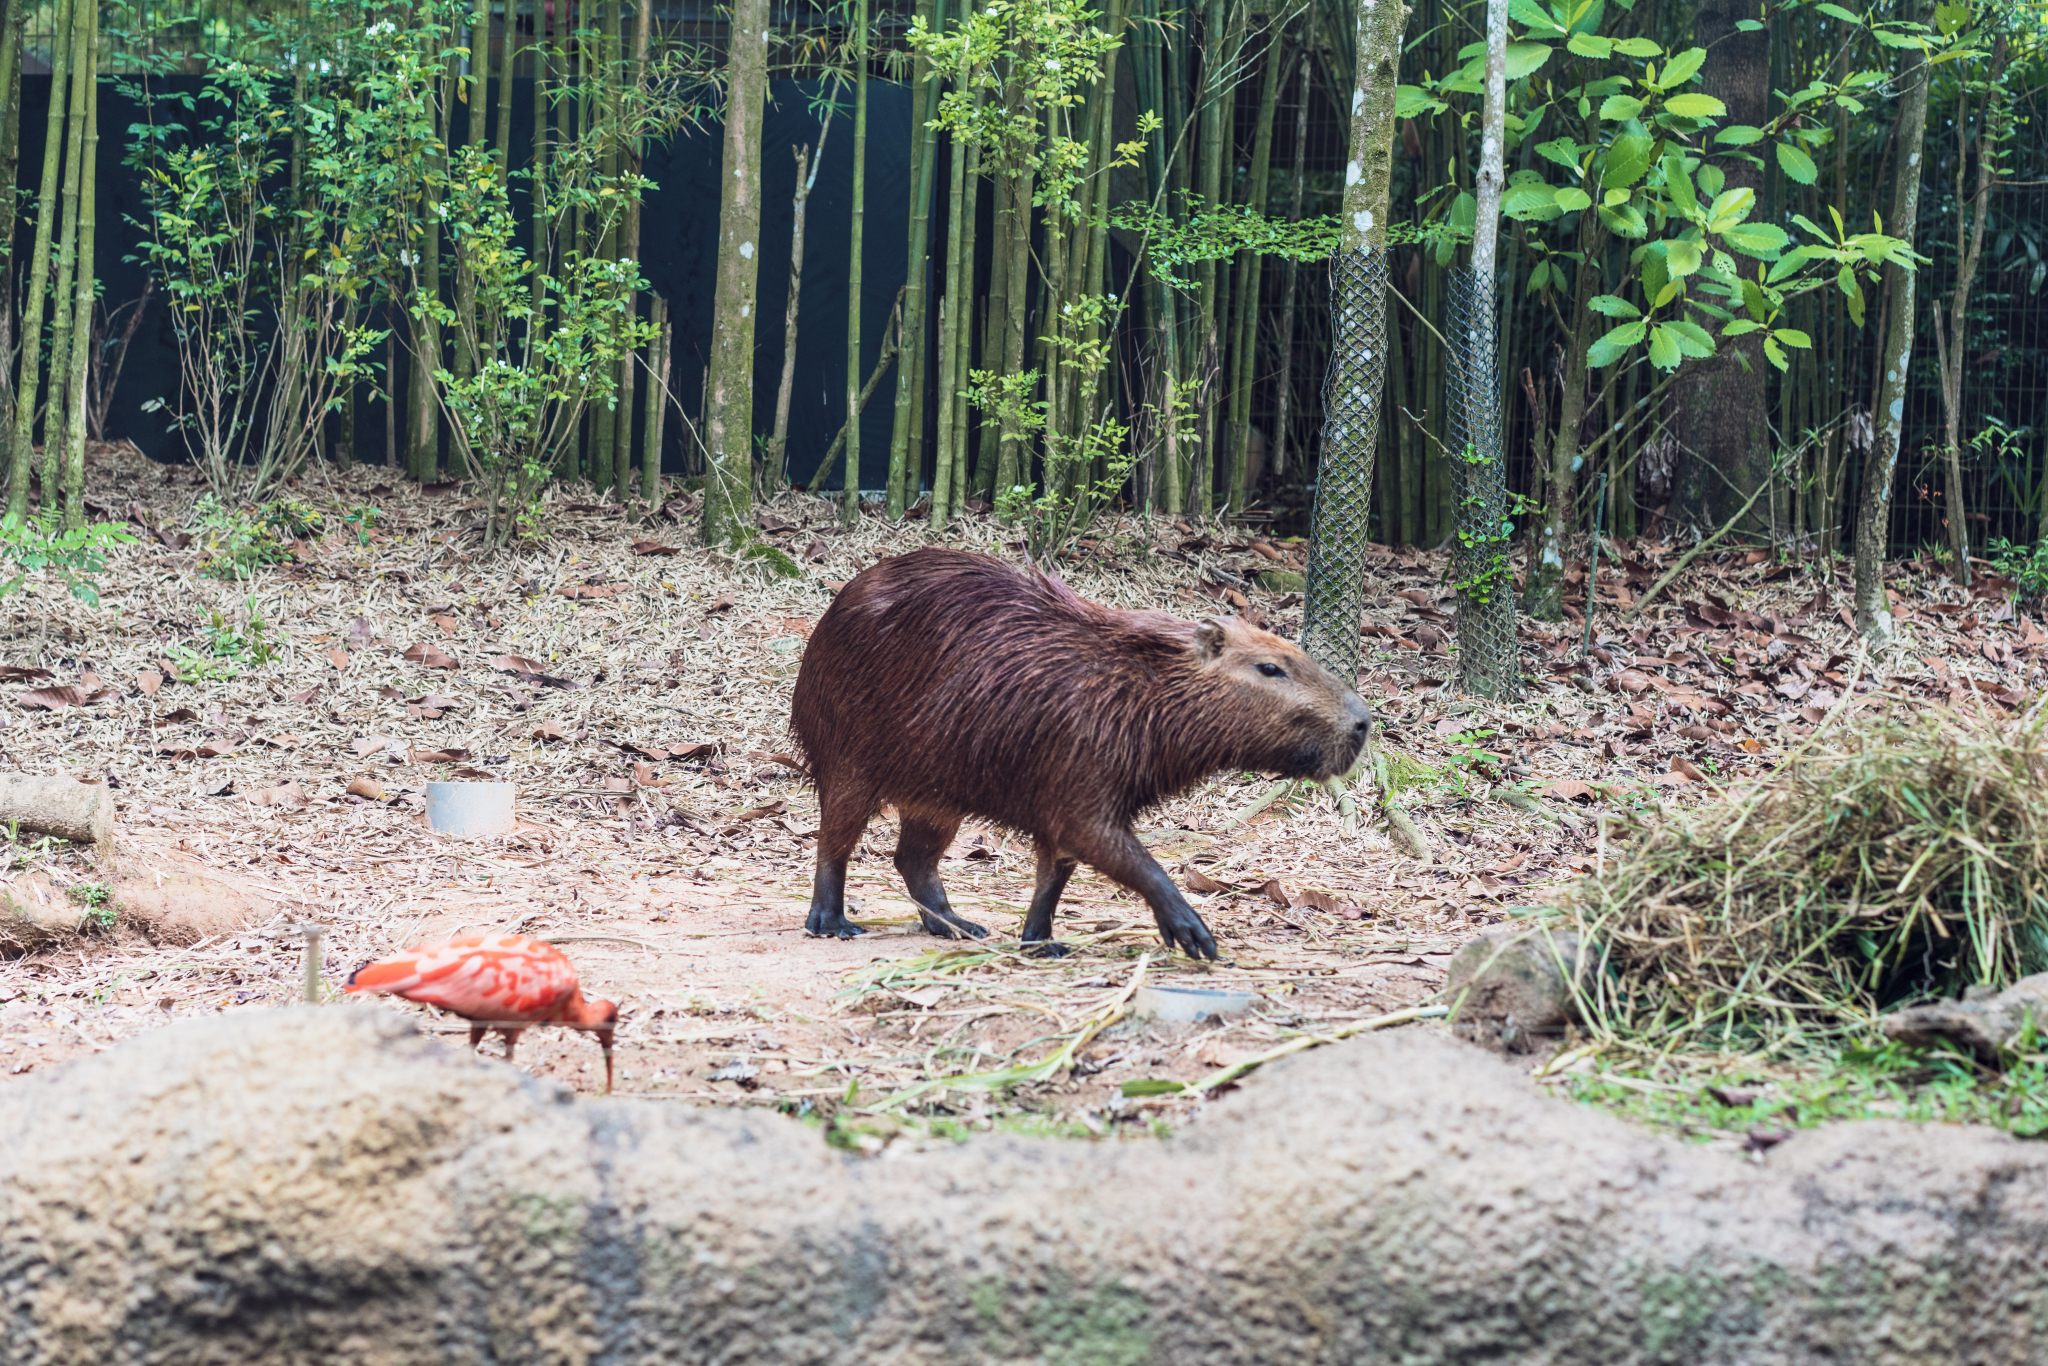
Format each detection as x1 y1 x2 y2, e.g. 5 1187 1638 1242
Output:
1300 248 1386 686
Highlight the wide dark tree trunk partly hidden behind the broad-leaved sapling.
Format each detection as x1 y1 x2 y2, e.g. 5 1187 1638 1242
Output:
1671 0 1776 532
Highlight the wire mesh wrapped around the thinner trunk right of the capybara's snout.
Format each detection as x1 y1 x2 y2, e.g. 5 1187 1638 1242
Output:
1444 268 1522 700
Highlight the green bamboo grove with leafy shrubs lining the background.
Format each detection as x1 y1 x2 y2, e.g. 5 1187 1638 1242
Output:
0 0 2048 629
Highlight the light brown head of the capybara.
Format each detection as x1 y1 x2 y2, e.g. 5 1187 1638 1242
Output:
1194 616 1372 778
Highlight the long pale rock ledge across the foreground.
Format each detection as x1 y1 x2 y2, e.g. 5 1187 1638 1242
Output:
0 1008 2048 1366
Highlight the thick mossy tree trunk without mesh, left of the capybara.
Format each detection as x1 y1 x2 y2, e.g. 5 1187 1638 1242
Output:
702 0 768 545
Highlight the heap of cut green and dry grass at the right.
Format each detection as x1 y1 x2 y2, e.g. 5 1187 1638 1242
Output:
1548 709 2048 1057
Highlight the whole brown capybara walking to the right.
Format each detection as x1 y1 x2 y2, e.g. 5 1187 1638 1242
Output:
791 549 1372 958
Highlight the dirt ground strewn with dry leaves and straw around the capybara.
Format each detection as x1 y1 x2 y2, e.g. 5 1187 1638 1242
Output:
0 446 2023 1130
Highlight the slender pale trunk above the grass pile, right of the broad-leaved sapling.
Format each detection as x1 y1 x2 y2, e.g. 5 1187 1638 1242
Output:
1855 2 1927 645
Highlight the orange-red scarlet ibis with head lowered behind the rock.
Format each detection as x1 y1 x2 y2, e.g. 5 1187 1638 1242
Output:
348 934 618 1094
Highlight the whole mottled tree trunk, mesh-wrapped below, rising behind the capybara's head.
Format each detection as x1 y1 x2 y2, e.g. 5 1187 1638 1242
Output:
1300 0 1407 686
